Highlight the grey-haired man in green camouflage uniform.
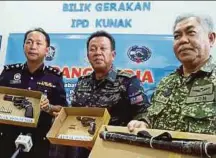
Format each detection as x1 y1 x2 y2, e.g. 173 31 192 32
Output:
140 14 216 134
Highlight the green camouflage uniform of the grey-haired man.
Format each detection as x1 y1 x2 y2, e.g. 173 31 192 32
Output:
147 57 216 134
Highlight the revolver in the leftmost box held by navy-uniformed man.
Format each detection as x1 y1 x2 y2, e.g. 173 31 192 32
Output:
3 94 33 118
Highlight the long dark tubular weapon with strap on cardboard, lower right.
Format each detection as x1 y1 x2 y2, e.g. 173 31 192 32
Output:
99 131 216 158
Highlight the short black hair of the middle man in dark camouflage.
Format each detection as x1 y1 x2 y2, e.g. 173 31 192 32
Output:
87 30 115 50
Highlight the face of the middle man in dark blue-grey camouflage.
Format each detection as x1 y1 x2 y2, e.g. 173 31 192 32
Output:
88 36 115 72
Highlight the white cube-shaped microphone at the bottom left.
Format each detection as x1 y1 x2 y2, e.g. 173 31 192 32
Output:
11 133 33 158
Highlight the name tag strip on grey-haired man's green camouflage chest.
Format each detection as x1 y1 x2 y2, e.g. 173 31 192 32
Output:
186 93 214 103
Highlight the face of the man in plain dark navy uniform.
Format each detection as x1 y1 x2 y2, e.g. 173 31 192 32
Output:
24 31 49 62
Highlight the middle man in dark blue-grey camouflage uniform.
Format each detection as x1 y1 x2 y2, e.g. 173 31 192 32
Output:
72 31 149 157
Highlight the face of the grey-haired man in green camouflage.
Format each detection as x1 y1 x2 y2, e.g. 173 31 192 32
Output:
173 17 214 65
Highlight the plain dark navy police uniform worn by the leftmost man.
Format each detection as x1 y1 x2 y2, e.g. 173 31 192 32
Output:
0 64 67 158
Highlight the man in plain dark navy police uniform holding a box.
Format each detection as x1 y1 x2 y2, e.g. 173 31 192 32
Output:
0 28 67 158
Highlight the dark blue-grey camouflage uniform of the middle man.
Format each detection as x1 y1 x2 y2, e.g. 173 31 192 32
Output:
72 66 149 126
